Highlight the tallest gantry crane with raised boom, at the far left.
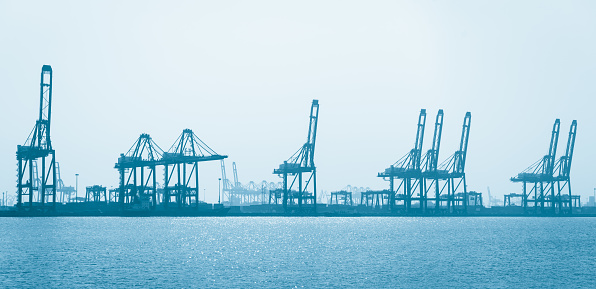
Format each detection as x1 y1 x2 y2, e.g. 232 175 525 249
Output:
16 65 56 209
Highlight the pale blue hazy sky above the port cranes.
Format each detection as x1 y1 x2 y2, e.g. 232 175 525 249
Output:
0 0 596 202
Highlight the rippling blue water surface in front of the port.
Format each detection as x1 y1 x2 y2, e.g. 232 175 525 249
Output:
0 217 596 288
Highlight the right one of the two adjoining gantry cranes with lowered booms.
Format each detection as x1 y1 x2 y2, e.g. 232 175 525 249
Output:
162 129 228 207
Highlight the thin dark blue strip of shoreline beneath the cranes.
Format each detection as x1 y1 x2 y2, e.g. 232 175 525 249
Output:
0 203 596 218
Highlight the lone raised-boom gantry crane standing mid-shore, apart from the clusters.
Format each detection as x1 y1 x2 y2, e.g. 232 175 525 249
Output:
273 99 319 212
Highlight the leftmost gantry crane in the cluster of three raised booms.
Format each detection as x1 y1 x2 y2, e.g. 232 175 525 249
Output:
377 109 426 212
